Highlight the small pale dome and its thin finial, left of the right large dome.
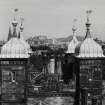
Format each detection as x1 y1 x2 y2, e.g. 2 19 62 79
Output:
66 19 79 54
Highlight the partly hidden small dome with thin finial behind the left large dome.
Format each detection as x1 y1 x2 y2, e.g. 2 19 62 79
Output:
18 18 32 53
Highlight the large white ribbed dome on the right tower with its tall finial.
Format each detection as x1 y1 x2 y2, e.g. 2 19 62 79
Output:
75 10 104 58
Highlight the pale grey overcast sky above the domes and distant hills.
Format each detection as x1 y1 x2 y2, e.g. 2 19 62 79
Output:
0 0 105 41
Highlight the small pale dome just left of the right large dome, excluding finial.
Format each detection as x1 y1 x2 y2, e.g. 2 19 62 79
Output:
66 36 79 53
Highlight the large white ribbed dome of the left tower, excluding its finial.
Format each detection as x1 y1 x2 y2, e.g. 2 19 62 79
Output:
0 38 29 58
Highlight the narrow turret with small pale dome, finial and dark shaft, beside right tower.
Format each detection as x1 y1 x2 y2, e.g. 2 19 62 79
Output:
62 19 79 84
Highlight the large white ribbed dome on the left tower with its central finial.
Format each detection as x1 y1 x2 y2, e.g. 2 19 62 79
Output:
0 11 29 58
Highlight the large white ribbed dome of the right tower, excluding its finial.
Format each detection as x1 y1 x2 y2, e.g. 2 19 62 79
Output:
75 38 104 57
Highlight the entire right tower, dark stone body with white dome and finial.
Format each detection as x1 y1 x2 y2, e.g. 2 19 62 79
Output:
76 10 105 105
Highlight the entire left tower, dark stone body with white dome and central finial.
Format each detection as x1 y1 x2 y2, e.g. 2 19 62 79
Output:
0 8 29 105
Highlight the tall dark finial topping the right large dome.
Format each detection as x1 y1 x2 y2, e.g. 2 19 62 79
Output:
85 10 92 38
